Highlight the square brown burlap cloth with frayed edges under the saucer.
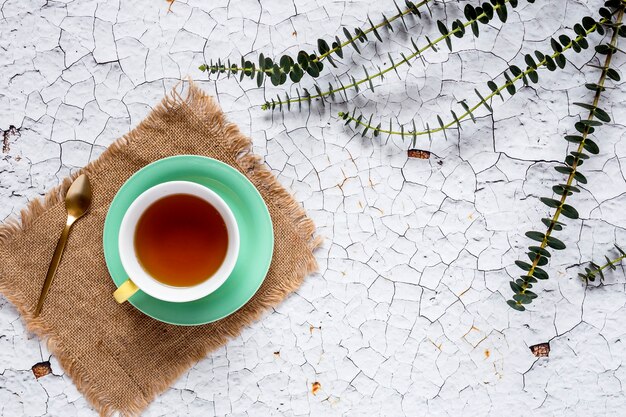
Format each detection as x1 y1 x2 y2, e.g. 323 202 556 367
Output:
0 85 319 416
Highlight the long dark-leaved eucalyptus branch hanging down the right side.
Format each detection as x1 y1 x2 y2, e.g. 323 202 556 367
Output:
507 0 626 311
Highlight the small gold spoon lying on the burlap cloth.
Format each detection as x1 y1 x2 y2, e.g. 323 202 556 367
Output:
35 174 91 317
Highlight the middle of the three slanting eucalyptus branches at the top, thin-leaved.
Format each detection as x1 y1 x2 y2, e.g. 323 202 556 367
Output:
261 0 535 110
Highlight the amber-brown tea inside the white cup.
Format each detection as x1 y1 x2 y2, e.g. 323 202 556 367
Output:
134 194 228 287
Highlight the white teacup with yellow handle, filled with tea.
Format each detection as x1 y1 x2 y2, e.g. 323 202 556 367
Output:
113 181 239 303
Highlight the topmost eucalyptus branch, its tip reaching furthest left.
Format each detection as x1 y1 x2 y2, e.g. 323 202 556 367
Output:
199 0 433 87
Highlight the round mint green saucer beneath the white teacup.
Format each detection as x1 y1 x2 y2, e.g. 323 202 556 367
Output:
103 155 274 326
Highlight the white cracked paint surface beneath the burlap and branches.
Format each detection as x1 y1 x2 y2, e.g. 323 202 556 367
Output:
0 0 626 417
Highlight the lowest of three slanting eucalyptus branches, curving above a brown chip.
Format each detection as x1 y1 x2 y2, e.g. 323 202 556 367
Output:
339 17 610 141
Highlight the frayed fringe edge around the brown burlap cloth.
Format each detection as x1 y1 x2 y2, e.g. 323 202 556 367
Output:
0 81 322 417
